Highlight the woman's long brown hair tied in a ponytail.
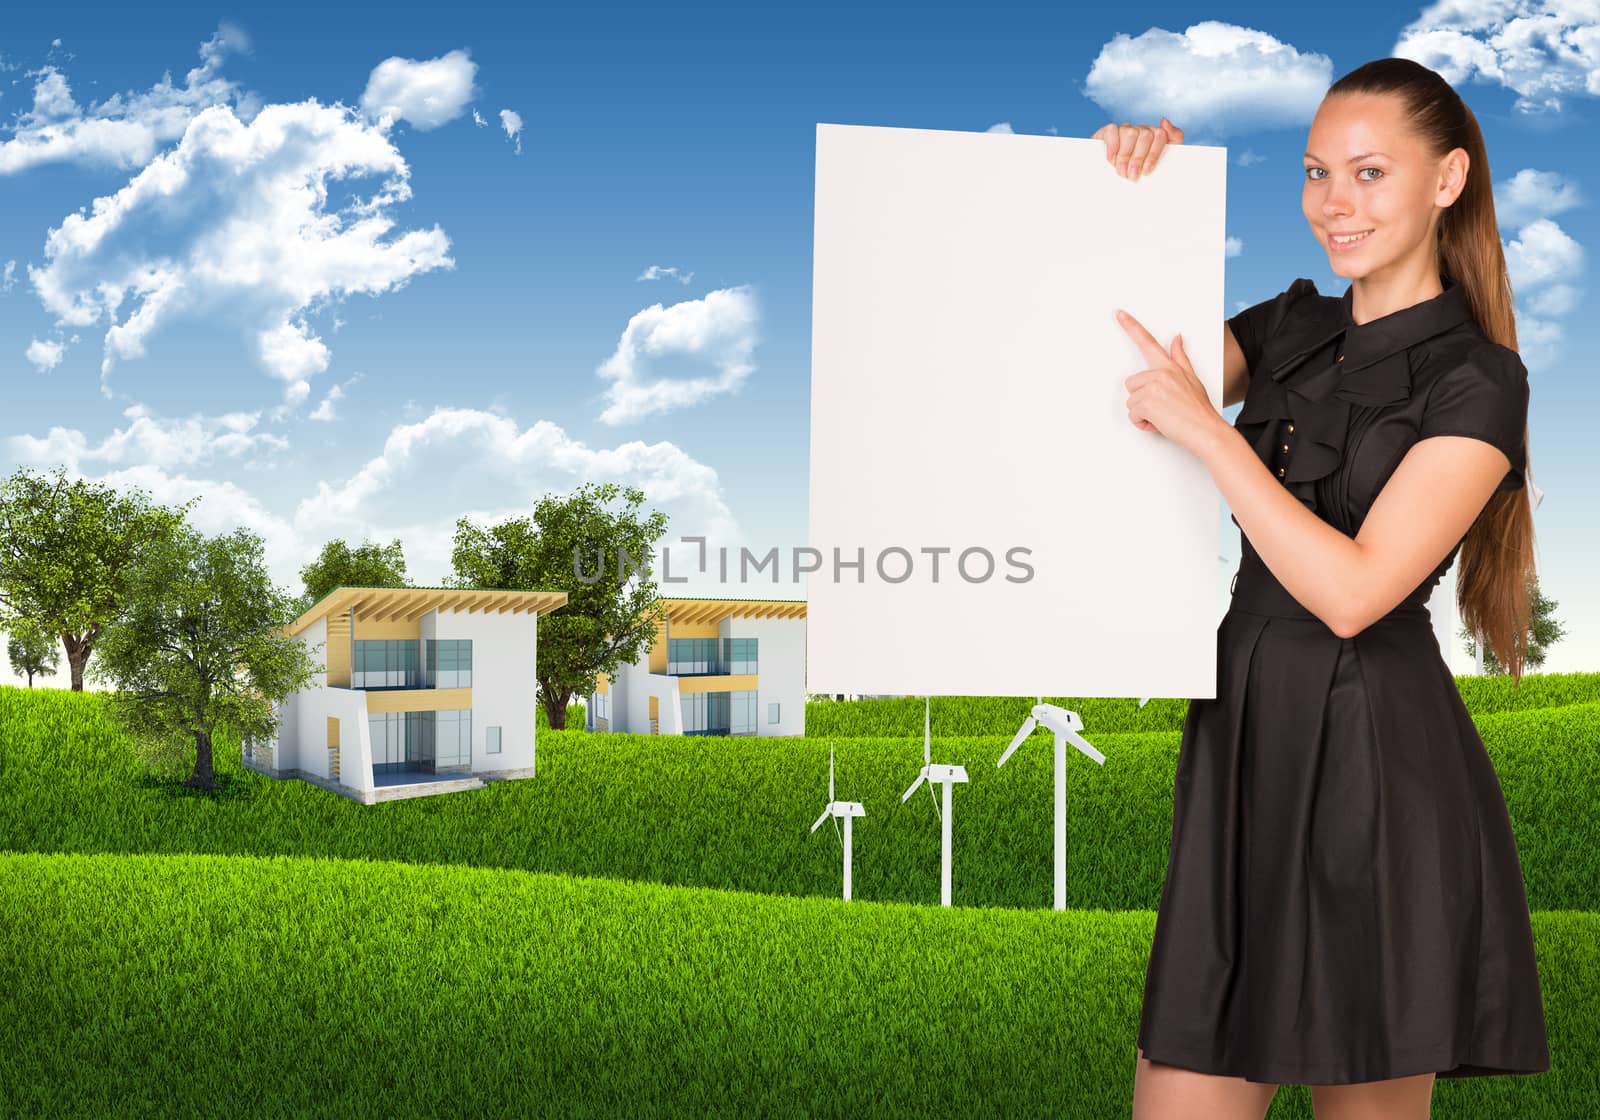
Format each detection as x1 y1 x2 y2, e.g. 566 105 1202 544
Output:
1325 58 1538 686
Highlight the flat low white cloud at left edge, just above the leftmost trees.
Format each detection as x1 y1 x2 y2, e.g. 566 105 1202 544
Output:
8 405 290 472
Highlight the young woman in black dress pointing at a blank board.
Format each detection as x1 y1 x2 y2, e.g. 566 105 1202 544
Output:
1096 58 1550 1120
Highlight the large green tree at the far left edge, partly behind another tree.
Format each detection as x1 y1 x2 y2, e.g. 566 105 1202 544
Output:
0 467 200 691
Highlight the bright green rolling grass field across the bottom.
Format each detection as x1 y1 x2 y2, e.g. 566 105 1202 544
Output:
0 675 1600 1118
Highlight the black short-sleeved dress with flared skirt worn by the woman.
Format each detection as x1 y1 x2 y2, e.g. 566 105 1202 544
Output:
1139 277 1550 1085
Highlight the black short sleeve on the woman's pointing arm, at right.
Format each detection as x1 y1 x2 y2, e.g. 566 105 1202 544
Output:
1418 342 1528 490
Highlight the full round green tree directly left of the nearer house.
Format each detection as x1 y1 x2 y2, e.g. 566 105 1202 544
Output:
93 526 322 789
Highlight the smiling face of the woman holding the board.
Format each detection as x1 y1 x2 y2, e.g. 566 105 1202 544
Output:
1301 94 1466 280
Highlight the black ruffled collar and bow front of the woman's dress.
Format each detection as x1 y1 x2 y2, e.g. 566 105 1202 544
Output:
1234 277 1472 510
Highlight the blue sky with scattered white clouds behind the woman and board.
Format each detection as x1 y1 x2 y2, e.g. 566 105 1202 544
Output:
0 3 1600 672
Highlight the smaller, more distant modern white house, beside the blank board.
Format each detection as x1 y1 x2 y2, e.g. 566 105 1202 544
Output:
584 598 805 736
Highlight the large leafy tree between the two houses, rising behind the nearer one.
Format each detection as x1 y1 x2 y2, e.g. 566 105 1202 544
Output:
450 483 667 730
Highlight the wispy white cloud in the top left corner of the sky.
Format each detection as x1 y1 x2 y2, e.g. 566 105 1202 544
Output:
0 22 258 174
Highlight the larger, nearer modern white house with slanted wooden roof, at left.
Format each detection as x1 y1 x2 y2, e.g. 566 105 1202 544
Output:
243 587 566 805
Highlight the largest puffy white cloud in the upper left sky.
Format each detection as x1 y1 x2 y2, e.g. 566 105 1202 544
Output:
29 101 454 403
